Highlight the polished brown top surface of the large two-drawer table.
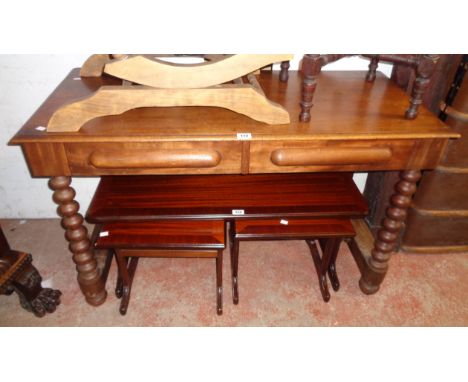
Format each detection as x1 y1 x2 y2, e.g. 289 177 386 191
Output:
10 69 459 144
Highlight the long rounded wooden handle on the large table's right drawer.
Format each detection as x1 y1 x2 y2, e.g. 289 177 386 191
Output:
271 147 392 166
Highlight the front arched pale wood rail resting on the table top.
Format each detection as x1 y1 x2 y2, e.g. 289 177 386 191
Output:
47 85 289 132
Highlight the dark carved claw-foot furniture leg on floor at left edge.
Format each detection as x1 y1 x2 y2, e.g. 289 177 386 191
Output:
0 227 62 317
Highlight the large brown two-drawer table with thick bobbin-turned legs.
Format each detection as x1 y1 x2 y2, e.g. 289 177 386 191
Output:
10 69 458 306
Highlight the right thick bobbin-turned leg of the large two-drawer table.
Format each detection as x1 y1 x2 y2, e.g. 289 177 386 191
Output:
359 170 421 294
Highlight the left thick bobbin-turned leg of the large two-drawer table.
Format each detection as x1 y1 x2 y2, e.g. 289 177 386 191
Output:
49 176 107 306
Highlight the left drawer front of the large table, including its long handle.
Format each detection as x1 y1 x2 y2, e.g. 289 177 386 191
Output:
65 142 242 175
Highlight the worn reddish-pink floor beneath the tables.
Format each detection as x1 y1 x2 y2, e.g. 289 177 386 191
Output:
0 219 468 326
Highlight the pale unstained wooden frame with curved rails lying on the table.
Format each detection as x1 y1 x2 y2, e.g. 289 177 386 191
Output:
47 54 292 132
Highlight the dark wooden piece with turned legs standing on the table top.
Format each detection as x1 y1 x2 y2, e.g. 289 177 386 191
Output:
299 54 438 122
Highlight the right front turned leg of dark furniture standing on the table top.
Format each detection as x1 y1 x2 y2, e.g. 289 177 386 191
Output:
405 54 439 119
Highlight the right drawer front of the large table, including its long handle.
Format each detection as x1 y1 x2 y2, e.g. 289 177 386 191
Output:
249 140 440 173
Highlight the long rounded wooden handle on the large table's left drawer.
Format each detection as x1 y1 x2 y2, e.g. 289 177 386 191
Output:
89 149 221 169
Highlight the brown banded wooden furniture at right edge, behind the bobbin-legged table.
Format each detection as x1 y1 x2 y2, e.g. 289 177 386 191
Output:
401 55 468 253
